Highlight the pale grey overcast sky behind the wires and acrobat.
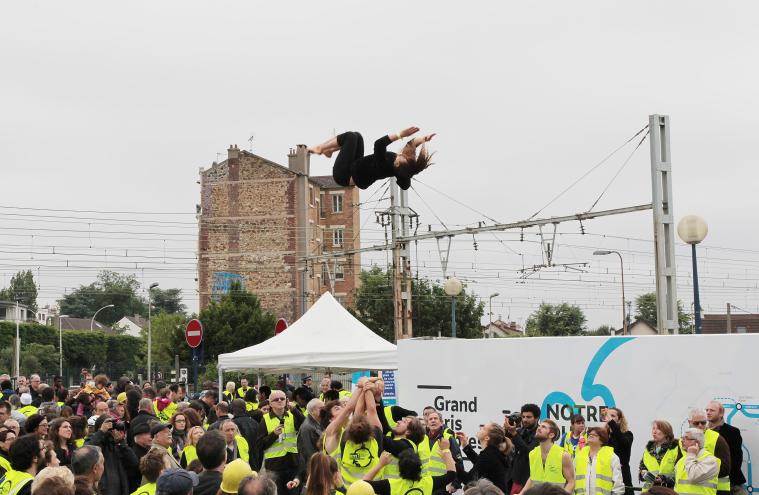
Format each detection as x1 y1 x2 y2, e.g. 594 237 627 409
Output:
0 1 759 328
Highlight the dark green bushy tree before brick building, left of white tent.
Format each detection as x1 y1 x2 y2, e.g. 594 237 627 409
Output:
199 282 277 361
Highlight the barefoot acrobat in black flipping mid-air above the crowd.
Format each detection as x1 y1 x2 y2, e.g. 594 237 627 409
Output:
308 127 435 190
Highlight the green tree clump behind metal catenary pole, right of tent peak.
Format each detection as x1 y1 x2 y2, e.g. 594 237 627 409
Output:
349 266 484 342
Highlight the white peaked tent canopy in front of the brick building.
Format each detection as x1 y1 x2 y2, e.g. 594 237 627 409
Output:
219 292 398 373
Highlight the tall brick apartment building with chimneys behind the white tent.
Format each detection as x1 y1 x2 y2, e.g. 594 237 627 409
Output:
198 145 361 322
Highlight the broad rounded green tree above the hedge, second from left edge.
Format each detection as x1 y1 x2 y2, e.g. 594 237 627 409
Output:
58 270 147 325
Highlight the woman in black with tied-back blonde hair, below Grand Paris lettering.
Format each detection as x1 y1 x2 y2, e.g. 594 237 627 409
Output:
456 423 513 493
